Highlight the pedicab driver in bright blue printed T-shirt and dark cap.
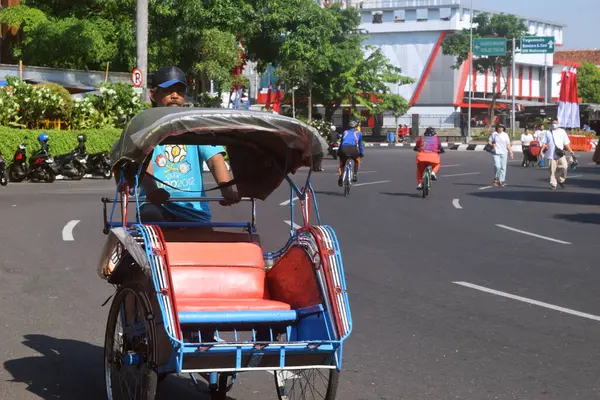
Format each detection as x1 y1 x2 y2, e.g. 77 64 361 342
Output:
140 67 240 222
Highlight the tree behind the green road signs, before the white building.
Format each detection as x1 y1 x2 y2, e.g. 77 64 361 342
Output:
442 13 528 128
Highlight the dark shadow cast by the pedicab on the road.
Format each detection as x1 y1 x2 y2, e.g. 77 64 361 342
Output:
4 335 234 400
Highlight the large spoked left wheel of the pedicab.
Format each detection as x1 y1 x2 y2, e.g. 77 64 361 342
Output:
104 286 158 400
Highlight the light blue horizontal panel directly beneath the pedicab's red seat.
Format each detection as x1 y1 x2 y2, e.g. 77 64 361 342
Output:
179 310 298 324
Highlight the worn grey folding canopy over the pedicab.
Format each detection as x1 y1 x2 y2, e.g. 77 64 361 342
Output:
111 107 327 200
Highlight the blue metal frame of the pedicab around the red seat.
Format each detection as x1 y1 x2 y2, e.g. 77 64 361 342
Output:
108 163 344 378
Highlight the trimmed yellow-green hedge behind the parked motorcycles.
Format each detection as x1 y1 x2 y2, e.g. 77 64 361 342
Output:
0 126 122 163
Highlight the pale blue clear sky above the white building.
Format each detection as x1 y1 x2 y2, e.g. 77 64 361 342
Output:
474 0 600 50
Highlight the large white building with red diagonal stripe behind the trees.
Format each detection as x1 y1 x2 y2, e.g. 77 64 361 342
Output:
347 0 564 128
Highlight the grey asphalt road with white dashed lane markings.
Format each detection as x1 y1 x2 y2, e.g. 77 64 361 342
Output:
0 149 600 400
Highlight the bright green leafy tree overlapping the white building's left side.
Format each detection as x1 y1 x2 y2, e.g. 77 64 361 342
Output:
278 5 412 121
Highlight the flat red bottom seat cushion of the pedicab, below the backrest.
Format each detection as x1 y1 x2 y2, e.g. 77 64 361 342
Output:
177 297 291 312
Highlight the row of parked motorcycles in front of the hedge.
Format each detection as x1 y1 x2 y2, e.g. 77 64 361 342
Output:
0 133 112 186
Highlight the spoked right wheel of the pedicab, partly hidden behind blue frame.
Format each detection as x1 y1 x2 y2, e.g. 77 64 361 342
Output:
275 368 340 400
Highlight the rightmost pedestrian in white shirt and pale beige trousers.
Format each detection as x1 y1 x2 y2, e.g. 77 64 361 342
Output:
542 119 575 190
